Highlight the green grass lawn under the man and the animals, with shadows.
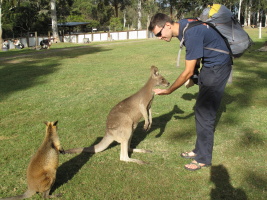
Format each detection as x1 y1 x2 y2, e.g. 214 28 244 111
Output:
0 29 267 200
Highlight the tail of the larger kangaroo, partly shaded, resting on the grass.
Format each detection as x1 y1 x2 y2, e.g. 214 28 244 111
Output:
65 135 114 154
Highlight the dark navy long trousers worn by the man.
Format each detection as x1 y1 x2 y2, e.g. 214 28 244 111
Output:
193 63 232 165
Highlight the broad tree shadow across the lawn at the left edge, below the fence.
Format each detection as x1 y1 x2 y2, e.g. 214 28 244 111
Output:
0 47 109 101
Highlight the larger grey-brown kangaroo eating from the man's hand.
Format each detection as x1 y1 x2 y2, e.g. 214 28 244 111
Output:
65 66 169 164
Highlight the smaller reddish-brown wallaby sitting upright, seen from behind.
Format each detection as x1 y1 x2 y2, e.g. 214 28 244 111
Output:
1 121 64 200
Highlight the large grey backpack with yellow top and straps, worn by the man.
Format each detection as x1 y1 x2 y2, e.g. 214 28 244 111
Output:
177 4 253 67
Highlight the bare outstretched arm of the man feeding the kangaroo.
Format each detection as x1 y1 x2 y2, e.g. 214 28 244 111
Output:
154 60 197 95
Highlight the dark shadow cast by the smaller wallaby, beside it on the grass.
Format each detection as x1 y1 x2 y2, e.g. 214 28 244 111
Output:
50 138 102 194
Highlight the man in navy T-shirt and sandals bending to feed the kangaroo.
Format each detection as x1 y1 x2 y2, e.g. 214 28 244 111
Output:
148 13 232 171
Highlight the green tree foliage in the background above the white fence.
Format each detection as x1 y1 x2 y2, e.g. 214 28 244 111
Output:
2 0 267 38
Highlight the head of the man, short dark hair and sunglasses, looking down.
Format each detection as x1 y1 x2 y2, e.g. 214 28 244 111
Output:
148 13 177 42
